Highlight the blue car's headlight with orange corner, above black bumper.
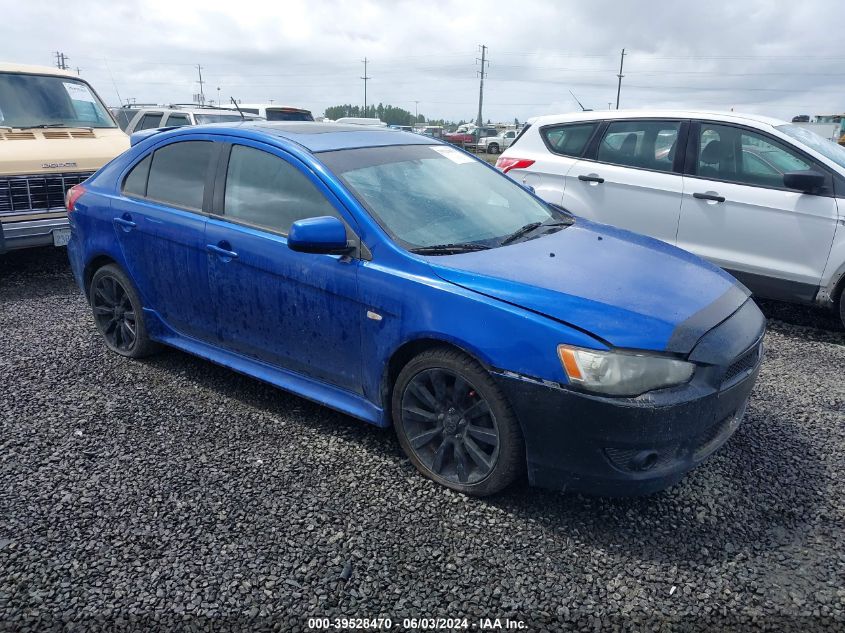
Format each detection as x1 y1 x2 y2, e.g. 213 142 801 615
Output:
557 345 695 396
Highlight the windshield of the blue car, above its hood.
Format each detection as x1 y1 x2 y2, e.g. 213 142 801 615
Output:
320 145 572 254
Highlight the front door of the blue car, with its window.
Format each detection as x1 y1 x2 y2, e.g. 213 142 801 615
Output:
206 141 366 393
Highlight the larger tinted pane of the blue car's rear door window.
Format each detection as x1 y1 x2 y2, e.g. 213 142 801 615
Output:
147 141 214 211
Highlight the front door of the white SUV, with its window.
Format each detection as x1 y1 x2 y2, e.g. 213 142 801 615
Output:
678 121 837 301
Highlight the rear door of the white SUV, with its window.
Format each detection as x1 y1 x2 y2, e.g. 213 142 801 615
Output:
563 119 687 244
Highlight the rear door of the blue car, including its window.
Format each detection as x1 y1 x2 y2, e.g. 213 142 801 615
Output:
112 137 218 340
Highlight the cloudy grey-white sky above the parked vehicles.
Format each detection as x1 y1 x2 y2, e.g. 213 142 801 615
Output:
6 0 845 121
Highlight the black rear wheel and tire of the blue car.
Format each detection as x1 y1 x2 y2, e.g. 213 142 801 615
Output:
88 264 158 358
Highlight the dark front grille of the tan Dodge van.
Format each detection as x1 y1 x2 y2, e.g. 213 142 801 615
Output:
0 171 94 215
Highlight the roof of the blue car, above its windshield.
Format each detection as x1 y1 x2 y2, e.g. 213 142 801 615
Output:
168 121 441 153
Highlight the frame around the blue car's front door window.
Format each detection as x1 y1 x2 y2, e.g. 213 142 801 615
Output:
208 139 362 244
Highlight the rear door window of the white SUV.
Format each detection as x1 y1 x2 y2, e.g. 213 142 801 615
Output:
596 120 681 171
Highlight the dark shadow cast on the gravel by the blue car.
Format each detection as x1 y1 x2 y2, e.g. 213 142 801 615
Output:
143 350 828 564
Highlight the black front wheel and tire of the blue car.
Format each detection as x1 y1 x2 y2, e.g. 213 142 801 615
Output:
391 348 525 496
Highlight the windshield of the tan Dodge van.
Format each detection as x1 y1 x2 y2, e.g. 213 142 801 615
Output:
0 72 117 128
